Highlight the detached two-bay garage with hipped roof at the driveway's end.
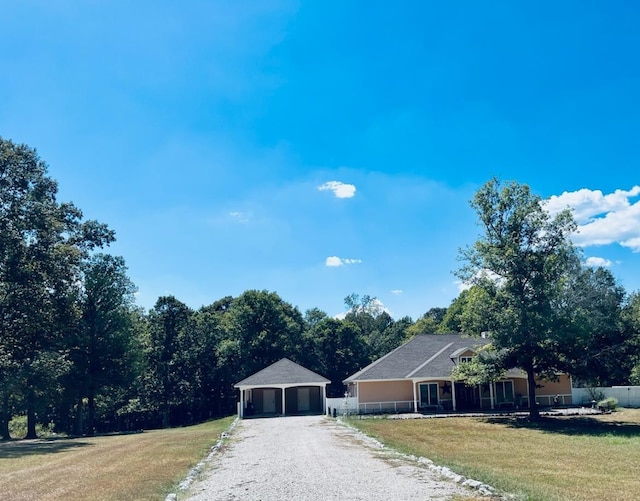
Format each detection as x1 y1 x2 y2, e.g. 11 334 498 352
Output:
234 358 331 418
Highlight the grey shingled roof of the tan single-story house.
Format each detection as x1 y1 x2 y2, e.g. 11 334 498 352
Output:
344 334 489 383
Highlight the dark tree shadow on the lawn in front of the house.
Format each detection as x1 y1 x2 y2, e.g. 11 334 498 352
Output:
487 416 640 438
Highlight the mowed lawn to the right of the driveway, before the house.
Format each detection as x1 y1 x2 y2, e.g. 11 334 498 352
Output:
350 409 640 501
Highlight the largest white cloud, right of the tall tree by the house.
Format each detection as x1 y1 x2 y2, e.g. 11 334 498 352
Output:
546 186 640 252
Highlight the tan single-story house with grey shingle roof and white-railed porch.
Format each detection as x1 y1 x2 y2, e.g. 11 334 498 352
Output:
343 334 571 413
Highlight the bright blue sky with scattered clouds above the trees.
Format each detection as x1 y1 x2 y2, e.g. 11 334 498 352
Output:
0 0 640 319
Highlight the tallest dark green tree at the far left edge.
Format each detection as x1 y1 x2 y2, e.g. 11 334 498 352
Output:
0 138 114 438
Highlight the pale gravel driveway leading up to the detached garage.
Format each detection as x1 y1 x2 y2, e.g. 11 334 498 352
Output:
180 416 478 501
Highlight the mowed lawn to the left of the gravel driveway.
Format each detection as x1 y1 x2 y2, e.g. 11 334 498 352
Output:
0 418 234 501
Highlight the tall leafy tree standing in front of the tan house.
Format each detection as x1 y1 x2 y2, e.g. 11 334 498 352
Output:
457 179 579 419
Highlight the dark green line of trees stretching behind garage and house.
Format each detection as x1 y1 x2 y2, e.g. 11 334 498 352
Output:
0 138 640 439
